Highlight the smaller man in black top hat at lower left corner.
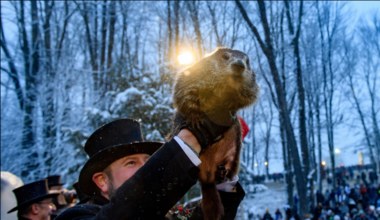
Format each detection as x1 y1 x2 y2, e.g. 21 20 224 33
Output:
8 179 58 220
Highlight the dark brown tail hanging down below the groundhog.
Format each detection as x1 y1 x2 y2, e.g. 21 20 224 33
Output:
201 183 224 220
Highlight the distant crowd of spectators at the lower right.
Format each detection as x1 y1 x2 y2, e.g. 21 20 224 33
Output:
249 166 380 220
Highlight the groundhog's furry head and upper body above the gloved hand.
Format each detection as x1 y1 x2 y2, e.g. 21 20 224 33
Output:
173 48 259 124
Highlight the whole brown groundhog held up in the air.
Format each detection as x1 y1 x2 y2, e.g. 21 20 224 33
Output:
169 48 259 220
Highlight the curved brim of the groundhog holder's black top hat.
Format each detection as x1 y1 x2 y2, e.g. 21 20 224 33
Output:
78 142 163 195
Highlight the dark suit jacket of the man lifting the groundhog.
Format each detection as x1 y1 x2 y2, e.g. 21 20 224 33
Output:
56 140 244 220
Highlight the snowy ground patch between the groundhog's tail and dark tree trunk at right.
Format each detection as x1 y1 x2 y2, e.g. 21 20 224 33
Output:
236 182 287 220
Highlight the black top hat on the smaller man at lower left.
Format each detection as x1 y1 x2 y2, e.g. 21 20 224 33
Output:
8 179 58 213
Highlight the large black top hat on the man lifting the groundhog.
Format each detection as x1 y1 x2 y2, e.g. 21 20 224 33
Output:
78 119 162 195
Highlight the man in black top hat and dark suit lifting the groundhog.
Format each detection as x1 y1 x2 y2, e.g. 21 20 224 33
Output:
57 119 245 220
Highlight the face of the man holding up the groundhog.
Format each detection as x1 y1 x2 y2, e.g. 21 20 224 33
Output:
105 154 150 197
